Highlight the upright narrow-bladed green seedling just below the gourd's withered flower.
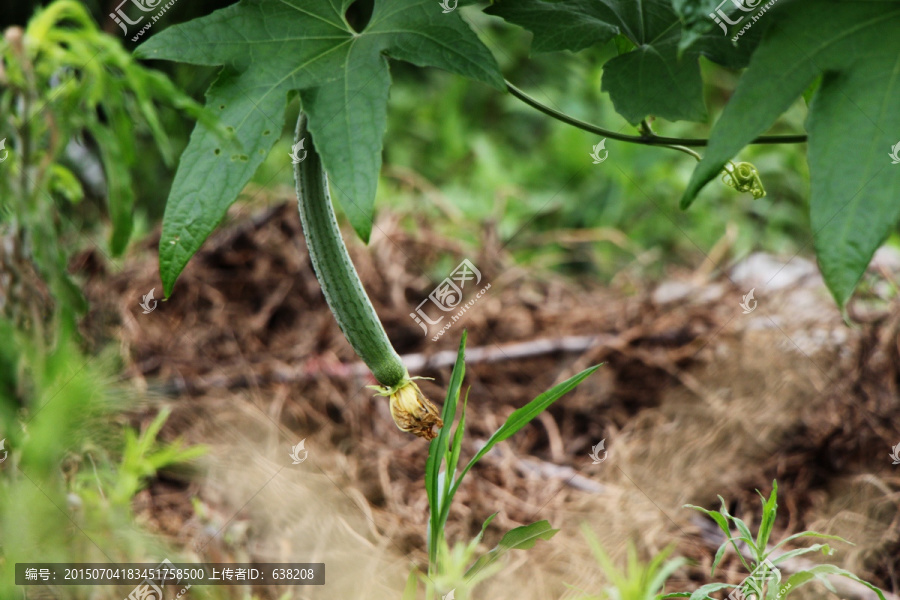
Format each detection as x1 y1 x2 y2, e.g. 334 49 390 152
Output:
412 332 600 600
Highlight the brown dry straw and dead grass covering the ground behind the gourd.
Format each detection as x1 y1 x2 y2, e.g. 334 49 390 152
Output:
78 203 900 600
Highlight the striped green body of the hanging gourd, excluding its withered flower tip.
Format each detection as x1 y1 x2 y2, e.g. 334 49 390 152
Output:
294 114 409 387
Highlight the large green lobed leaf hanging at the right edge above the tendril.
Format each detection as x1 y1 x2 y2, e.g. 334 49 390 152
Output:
681 0 900 307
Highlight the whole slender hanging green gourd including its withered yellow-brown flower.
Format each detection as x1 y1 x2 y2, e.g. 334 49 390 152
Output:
294 113 444 440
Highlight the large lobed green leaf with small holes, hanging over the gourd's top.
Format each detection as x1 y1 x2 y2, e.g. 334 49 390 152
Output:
135 0 503 296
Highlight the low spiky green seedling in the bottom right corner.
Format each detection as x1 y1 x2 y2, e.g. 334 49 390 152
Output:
663 480 885 600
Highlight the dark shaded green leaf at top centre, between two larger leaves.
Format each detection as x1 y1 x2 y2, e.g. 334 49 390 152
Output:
486 0 761 123
